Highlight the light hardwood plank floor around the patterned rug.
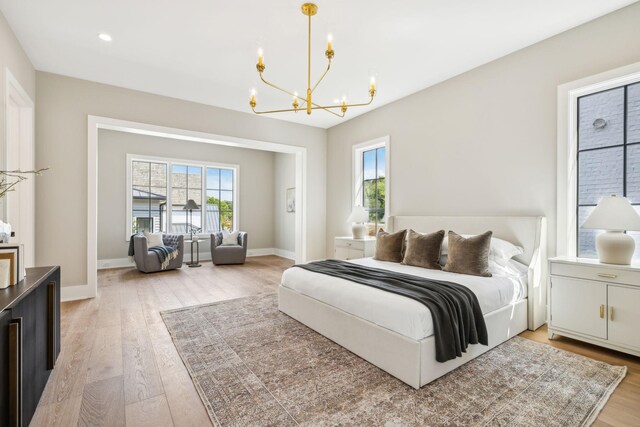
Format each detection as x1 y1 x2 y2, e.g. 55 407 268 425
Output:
32 256 640 427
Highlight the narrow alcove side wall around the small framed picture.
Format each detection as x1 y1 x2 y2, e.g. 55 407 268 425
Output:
274 153 296 256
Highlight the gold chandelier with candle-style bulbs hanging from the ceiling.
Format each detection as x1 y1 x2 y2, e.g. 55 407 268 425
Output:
249 3 376 117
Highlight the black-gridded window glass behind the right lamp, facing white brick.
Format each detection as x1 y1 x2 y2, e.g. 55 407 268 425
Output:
576 83 640 258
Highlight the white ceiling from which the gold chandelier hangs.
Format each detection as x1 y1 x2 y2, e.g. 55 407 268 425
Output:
0 0 636 128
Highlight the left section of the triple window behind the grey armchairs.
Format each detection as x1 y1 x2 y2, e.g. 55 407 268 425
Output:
131 161 167 234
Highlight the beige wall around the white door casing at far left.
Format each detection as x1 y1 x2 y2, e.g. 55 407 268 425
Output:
0 12 35 219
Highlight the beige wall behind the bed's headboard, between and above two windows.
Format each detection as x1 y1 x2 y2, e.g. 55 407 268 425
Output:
327 4 640 254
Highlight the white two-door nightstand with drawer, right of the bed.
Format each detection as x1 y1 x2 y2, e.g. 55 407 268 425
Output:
549 258 640 356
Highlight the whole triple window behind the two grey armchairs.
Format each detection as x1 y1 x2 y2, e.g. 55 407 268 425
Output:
127 155 238 240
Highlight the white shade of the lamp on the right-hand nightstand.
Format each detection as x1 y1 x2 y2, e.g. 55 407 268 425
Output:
582 195 640 231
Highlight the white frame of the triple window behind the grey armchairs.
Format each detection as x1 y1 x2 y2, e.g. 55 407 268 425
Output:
125 153 240 242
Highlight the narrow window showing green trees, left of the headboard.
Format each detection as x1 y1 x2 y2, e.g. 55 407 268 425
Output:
354 138 389 236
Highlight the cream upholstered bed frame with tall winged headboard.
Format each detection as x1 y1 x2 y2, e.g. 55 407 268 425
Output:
278 216 547 389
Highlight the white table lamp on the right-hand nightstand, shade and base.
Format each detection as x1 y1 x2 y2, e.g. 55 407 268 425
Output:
582 194 640 265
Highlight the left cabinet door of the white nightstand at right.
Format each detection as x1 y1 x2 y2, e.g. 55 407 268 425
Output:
551 277 607 339
